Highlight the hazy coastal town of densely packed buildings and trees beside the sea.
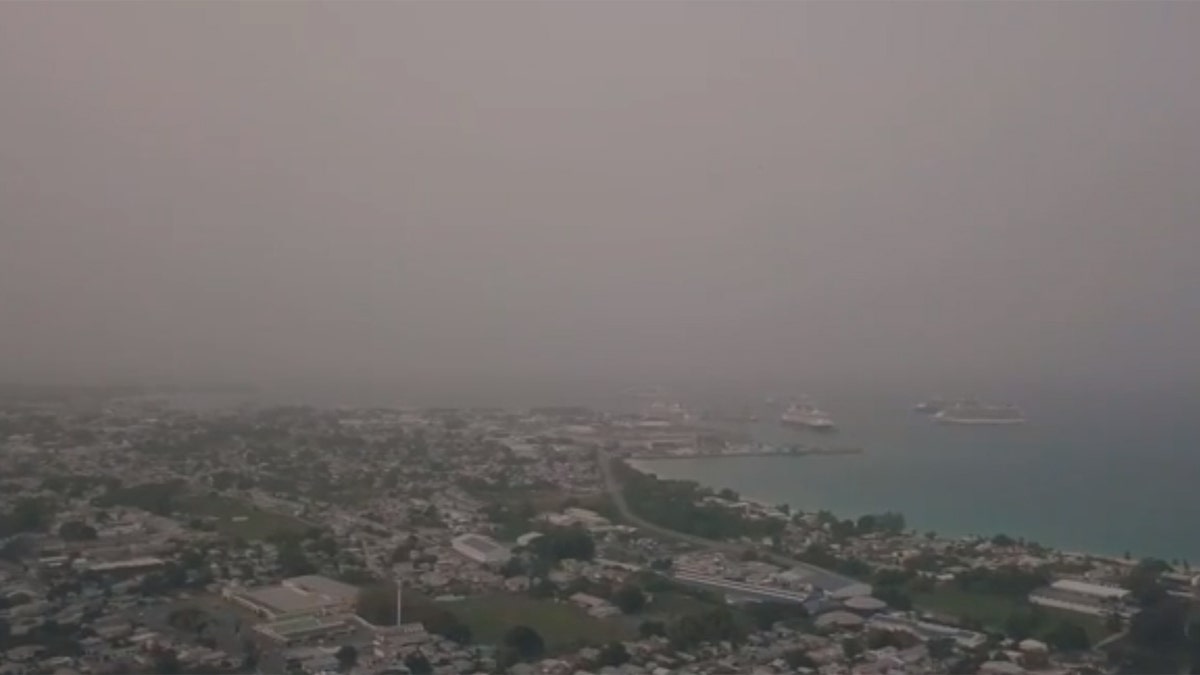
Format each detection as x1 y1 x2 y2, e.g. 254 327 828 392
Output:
0 389 1200 675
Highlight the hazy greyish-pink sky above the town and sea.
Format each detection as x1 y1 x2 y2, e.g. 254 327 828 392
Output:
0 1 1200 393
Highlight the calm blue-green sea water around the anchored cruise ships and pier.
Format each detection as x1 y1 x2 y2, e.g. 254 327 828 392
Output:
638 390 1200 563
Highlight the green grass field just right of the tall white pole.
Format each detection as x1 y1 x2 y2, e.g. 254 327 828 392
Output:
439 595 632 652
